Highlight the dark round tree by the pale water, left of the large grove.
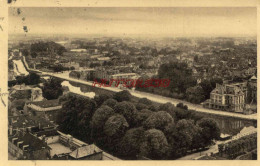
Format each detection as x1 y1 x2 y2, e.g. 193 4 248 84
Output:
42 78 63 100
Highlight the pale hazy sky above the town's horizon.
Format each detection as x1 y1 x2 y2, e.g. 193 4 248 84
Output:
9 7 257 37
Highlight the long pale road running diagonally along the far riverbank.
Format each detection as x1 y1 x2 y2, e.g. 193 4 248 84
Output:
32 70 257 120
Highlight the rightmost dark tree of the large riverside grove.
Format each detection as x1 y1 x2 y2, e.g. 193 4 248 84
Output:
198 118 220 146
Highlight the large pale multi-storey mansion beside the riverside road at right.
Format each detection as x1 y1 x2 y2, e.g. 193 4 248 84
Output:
203 84 245 113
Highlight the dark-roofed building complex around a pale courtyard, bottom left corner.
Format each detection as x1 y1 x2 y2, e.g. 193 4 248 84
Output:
8 123 103 160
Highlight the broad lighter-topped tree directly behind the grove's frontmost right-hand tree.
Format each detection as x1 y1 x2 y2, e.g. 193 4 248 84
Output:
143 111 174 131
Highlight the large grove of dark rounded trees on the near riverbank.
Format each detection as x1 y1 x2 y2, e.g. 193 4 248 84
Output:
57 91 220 159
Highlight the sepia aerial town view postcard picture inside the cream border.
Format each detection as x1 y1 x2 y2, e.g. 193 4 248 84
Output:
5 6 257 161
